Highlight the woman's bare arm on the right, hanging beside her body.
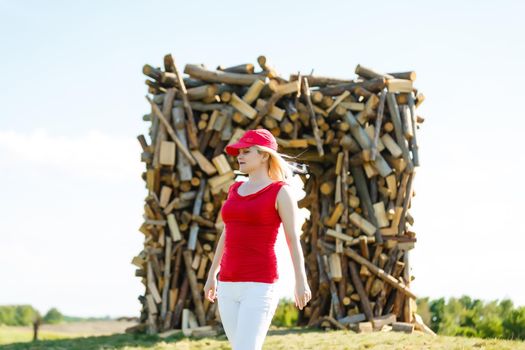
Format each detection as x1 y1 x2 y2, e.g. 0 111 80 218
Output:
277 185 312 310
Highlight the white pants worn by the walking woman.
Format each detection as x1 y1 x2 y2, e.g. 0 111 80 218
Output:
217 281 280 350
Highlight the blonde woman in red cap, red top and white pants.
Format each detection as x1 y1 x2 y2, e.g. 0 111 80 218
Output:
204 129 312 350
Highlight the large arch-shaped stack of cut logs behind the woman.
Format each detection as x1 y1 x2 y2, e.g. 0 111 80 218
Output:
129 55 429 335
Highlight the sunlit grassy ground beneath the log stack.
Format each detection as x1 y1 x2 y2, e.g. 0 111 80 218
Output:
0 325 525 350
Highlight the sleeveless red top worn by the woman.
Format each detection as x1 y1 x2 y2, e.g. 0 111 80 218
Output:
218 181 286 283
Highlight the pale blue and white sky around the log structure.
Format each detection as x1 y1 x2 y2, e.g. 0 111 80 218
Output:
0 0 525 316
